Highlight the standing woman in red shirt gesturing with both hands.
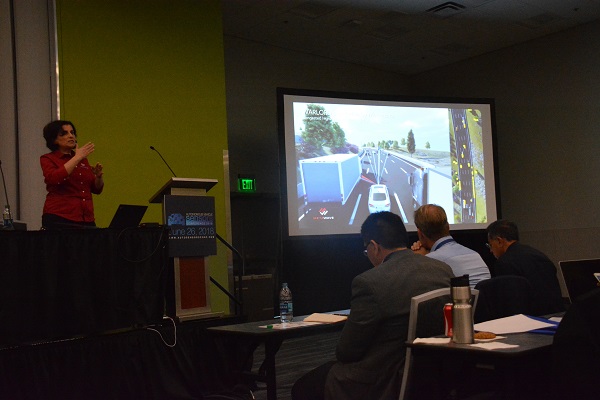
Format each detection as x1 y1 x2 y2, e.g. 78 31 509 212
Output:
40 120 104 229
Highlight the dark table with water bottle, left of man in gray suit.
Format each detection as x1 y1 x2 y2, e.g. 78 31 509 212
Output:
207 311 347 400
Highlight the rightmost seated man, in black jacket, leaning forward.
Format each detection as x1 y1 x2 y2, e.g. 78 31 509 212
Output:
487 220 565 315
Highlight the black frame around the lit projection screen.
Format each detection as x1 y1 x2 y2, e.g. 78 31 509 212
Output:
277 87 501 240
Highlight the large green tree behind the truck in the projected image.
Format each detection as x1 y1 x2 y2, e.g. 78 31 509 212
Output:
302 104 346 150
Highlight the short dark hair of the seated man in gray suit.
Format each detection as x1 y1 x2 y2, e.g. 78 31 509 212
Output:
360 211 408 249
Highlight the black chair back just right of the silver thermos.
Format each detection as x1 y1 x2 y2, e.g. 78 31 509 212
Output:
474 275 533 323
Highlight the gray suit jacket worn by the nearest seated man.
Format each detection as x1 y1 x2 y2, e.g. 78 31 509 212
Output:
325 250 454 400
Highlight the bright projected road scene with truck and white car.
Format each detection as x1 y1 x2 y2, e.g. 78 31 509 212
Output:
286 96 488 235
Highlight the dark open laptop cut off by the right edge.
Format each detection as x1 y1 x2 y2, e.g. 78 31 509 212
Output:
558 258 600 303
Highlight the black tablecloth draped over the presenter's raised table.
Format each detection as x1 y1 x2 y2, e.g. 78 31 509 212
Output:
0 228 168 346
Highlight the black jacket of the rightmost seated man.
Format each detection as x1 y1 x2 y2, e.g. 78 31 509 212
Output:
495 242 565 315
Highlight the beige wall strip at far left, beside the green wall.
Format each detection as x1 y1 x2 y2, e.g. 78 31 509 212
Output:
0 0 56 225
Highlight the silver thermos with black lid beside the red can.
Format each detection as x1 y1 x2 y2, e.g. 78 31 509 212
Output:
450 275 474 343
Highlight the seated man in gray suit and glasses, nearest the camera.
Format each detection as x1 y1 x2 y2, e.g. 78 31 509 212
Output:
292 212 454 400
